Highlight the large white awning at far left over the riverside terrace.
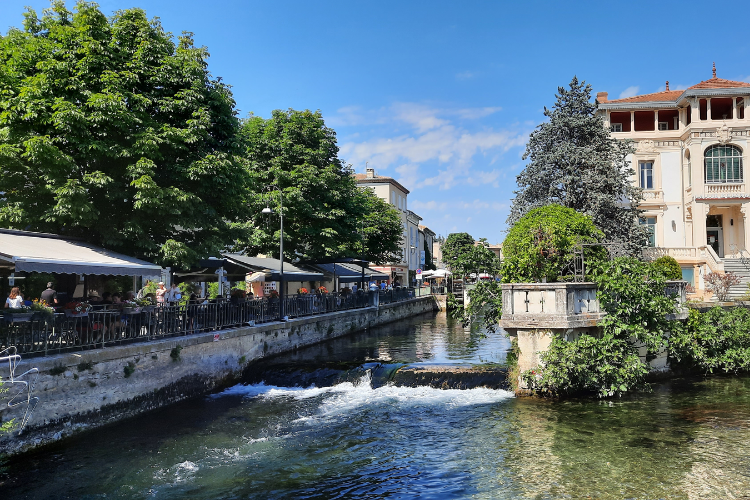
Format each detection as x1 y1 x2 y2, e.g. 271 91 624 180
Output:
0 229 161 276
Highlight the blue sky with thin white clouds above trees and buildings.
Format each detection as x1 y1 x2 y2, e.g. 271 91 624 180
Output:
0 0 750 242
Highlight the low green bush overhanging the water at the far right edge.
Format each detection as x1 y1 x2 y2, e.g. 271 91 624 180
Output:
669 307 750 373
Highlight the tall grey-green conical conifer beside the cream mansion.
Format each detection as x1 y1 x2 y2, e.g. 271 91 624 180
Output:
508 77 648 254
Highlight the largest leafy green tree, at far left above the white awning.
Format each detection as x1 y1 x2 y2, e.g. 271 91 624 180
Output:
0 1 253 265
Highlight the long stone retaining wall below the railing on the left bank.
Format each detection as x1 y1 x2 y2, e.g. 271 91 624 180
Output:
0 296 437 455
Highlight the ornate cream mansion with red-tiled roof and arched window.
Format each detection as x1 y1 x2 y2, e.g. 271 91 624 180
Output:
597 66 750 291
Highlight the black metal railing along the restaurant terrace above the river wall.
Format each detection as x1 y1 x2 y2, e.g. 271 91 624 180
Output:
0 288 424 355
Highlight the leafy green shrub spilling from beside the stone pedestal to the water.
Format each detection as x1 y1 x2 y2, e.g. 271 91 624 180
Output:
523 257 681 397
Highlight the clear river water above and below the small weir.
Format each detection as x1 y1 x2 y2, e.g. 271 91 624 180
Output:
0 315 750 499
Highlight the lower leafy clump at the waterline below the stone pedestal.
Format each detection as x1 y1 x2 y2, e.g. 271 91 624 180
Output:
523 335 648 397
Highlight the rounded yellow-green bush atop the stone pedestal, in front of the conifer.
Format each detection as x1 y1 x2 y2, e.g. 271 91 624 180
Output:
501 205 606 283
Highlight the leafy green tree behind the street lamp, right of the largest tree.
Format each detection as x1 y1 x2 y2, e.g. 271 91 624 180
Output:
237 109 401 262
